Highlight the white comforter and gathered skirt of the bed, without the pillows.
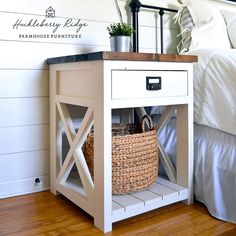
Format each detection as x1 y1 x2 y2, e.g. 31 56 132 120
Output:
155 49 236 223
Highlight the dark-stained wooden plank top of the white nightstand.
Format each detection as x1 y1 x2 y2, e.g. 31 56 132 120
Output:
47 51 197 64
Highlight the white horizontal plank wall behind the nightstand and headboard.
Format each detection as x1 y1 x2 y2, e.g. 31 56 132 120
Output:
0 0 182 198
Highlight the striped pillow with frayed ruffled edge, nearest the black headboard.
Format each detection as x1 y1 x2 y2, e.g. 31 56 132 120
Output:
177 7 194 53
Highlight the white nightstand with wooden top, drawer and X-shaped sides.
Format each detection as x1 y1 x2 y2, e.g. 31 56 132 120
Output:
48 52 197 232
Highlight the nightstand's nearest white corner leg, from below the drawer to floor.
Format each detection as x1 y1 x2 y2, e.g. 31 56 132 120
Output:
94 104 112 232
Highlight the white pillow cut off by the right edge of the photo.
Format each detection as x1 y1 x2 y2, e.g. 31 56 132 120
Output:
221 10 236 48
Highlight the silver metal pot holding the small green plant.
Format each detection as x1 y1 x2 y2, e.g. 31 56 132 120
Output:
110 35 130 52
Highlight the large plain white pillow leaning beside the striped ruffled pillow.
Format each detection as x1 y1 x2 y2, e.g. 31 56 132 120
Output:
177 0 231 51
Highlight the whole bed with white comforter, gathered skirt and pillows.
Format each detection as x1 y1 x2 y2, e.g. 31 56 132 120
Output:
130 0 236 223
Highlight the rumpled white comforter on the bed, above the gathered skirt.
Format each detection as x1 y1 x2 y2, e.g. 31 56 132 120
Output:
188 49 236 135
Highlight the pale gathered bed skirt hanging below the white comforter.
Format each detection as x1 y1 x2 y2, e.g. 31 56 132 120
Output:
154 115 236 223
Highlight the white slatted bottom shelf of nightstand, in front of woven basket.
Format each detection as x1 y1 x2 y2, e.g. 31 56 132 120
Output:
112 177 188 222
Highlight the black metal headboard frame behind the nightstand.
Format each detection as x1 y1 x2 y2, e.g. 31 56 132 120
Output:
129 0 177 53
